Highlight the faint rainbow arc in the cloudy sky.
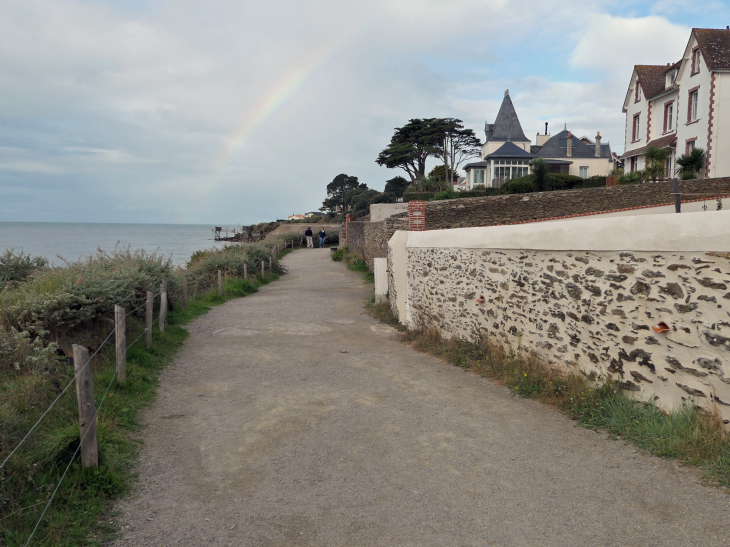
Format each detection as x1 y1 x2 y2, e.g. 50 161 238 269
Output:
213 24 363 171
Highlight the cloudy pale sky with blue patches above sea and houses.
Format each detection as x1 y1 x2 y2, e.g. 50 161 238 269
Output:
0 0 730 225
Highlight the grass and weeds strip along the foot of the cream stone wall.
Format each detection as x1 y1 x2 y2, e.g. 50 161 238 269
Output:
367 303 730 488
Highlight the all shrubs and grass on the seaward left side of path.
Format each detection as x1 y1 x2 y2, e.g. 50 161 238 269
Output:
0 239 286 546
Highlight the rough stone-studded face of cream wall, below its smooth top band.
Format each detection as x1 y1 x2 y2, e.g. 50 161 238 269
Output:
406 248 730 423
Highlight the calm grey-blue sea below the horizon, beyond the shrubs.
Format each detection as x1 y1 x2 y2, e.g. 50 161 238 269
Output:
0 222 224 266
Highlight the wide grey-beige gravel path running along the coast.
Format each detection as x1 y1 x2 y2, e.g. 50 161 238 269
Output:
113 250 730 547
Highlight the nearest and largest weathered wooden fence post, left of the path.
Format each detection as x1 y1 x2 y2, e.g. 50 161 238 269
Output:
73 344 99 467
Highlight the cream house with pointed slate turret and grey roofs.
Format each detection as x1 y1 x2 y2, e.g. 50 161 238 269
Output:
460 90 614 190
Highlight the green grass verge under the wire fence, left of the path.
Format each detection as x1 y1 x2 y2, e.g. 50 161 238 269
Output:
0 274 279 546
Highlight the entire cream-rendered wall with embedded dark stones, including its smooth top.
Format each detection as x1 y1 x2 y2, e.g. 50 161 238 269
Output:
388 211 730 424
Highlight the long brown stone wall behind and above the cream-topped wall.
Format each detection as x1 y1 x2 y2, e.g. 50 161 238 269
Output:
426 178 730 230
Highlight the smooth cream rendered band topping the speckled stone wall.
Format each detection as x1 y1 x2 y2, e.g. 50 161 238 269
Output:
407 211 730 252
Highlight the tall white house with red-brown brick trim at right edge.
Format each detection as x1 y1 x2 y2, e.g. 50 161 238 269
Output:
622 28 730 177
